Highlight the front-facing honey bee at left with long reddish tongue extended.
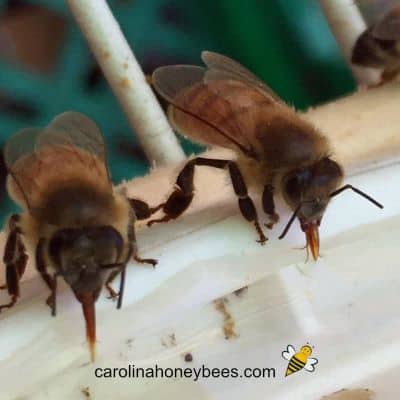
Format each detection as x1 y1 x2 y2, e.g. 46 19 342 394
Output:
0 112 157 361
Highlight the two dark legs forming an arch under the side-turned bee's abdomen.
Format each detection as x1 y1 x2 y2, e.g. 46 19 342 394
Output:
147 157 267 244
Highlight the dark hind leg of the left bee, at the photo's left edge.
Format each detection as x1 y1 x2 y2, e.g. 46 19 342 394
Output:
0 214 28 311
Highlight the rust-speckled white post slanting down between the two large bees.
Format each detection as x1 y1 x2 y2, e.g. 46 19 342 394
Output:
66 0 184 165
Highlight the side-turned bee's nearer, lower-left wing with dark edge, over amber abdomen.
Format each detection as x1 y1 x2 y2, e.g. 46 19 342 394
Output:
153 65 253 154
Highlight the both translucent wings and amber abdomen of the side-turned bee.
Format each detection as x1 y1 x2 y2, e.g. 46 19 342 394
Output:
152 52 289 158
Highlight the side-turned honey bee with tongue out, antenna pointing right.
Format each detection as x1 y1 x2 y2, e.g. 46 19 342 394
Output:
148 51 382 259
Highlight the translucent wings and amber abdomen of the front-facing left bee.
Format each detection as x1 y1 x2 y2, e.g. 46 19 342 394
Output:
4 112 112 210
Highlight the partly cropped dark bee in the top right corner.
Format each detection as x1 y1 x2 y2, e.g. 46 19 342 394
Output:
351 6 400 83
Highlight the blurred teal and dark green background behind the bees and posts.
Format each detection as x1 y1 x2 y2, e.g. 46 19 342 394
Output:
0 0 382 218
